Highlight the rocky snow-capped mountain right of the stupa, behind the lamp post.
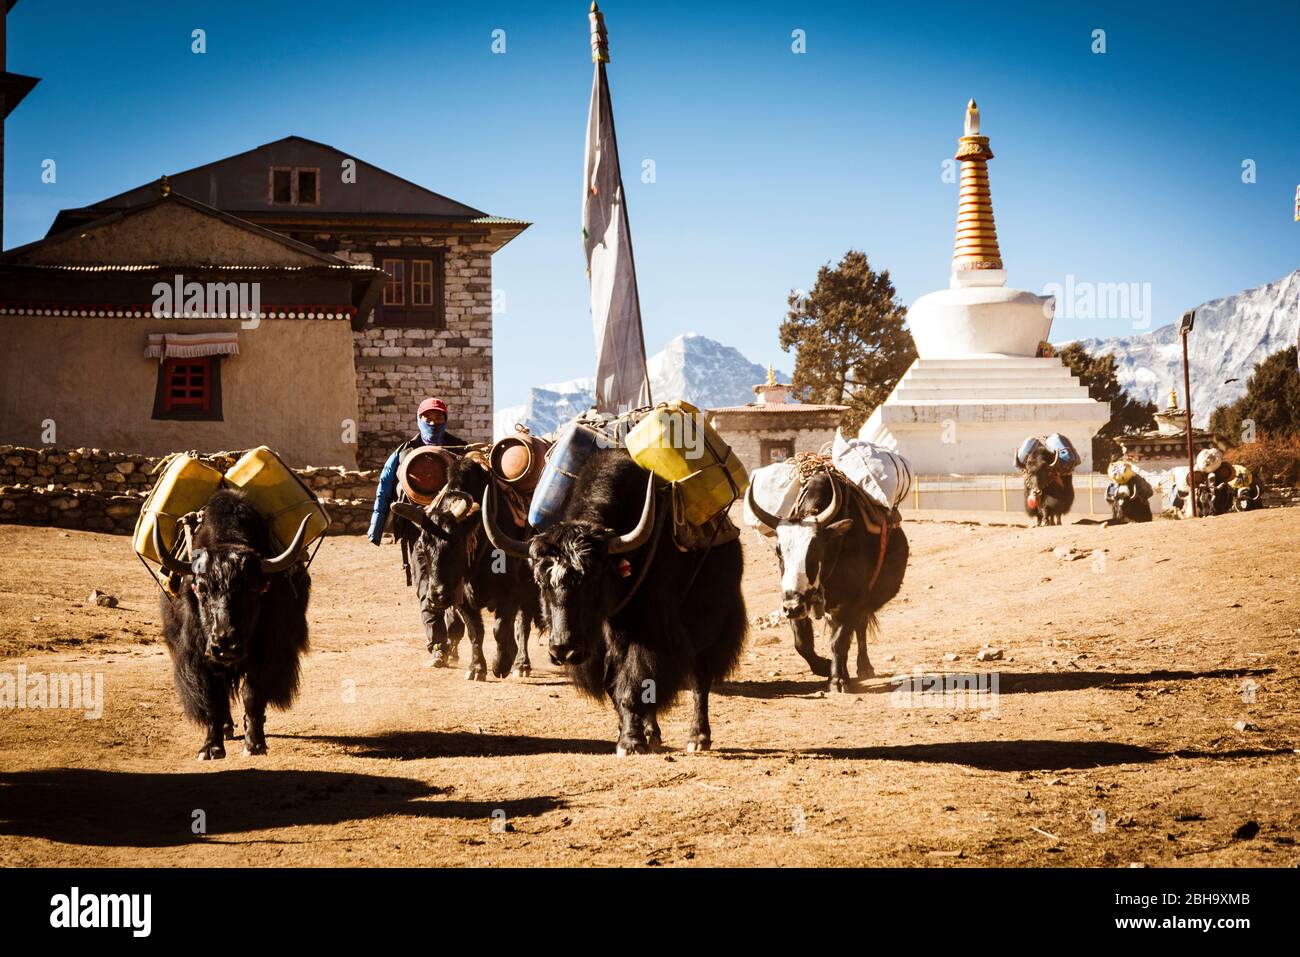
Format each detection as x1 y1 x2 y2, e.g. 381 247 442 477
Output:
1080 269 1300 426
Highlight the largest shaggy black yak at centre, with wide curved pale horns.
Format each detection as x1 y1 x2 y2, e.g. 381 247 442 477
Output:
484 449 746 754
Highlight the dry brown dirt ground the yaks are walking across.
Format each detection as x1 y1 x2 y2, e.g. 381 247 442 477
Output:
0 510 1300 866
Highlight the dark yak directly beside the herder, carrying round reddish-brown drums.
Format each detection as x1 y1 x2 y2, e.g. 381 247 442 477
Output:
393 455 541 681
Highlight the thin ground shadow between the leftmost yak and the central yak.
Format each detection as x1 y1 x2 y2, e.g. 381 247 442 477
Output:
297 731 614 761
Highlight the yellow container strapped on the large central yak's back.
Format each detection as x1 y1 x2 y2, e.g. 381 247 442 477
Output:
624 402 749 525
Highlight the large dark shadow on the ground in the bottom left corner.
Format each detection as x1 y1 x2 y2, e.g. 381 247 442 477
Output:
0 767 564 848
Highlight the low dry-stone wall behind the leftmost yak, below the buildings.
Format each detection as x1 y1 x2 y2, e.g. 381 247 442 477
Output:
0 445 380 534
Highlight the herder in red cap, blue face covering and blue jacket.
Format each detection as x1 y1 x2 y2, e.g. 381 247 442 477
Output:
367 398 465 667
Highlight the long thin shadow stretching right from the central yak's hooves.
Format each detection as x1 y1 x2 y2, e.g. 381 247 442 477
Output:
715 740 1291 771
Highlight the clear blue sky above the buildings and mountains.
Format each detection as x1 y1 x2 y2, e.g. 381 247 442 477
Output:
4 0 1300 404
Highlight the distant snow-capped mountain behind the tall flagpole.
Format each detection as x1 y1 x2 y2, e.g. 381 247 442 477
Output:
493 333 790 438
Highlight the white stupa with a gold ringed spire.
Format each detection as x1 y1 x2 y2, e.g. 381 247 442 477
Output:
858 100 1110 475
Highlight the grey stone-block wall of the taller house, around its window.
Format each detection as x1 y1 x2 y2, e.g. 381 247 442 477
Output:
332 235 494 467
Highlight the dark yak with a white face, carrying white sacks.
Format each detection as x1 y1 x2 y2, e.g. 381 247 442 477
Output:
745 472 909 692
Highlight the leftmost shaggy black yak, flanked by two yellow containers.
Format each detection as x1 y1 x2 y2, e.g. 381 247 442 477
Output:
153 489 312 761
